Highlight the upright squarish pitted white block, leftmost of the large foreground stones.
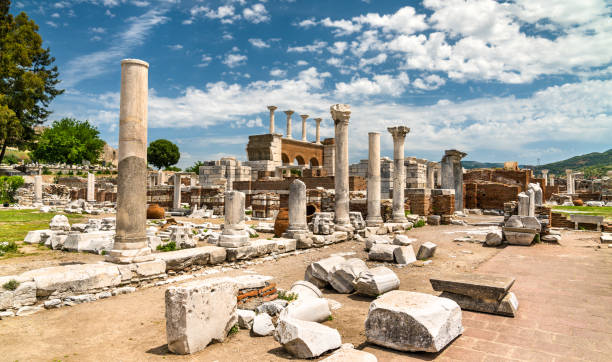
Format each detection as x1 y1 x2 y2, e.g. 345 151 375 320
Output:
166 278 238 354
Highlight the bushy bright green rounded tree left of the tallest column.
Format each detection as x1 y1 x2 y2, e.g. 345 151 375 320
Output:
32 118 104 165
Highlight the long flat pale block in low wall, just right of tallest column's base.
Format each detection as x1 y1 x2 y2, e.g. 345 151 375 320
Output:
155 246 226 270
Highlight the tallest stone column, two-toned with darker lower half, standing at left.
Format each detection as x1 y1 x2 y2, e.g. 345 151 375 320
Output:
107 59 153 263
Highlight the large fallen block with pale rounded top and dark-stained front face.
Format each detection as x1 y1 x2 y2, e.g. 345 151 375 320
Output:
365 290 463 352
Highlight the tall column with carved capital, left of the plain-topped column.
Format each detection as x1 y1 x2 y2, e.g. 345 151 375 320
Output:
330 104 351 225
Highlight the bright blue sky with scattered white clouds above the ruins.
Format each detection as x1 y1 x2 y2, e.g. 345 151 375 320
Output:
11 0 612 167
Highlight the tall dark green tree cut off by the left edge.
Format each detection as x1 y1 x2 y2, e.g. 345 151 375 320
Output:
0 0 64 162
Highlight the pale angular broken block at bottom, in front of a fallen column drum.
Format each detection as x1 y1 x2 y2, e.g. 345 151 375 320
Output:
274 318 342 358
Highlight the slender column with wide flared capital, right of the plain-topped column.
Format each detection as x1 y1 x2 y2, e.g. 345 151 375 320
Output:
387 126 410 223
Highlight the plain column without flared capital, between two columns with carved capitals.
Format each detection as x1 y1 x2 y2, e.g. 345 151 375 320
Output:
366 132 383 226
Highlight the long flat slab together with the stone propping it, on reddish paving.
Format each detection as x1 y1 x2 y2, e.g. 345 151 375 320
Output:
429 274 518 317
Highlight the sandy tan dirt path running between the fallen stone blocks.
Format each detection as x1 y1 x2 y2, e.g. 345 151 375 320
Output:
0 221 612 361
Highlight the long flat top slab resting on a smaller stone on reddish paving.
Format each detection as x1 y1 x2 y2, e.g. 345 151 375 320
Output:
429 273 514 301
